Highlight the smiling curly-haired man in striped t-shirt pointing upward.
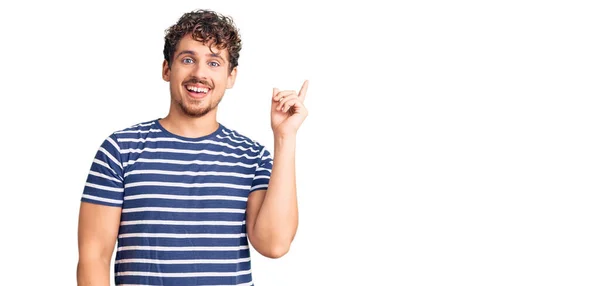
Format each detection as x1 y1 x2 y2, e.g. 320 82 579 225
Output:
77 10 308 285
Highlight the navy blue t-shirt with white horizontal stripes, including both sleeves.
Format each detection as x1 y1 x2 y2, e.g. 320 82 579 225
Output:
81 119 273 285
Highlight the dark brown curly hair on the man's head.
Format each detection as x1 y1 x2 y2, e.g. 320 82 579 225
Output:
163 9 242 72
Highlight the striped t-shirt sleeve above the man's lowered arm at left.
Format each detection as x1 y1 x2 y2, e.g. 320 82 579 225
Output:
81 134 123 207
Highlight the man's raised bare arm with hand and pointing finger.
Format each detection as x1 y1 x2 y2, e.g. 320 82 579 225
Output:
246 81 308 258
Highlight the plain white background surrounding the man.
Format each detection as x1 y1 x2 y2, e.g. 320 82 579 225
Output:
0 1 600 286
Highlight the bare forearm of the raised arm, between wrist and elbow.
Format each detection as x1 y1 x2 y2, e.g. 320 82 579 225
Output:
254 136 298 252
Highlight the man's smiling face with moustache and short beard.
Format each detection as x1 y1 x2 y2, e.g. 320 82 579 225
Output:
163 34 237 117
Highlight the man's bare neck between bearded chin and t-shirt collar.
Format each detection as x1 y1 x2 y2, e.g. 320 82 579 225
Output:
160 110 219 138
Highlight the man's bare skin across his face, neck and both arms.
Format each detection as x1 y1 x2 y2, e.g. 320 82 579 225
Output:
77 35 308 286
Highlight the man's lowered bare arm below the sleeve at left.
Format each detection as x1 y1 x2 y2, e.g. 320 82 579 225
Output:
77 202 121 286
